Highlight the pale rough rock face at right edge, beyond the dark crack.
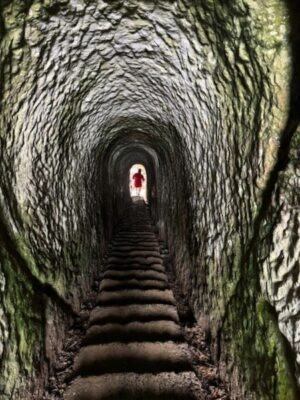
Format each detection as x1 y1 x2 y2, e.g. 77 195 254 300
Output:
260 124 300 382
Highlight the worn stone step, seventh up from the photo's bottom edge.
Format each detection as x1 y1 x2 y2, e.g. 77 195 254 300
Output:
103 269 168 282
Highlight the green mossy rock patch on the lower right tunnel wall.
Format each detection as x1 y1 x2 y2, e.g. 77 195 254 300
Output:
222 265 298 400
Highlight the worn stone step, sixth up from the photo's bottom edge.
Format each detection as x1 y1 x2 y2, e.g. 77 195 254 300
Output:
100 279 170 291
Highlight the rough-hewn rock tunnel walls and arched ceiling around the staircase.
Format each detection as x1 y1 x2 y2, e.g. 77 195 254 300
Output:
0 0 300 400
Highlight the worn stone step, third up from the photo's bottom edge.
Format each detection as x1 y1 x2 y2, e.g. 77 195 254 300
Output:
84 320 183 345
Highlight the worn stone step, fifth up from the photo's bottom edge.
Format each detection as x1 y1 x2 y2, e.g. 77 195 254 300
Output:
97 289 176 305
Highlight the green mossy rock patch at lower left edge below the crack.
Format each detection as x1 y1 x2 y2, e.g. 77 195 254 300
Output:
0 255 43 393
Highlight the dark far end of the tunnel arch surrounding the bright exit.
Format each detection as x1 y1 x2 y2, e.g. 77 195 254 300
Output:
95 120 191 247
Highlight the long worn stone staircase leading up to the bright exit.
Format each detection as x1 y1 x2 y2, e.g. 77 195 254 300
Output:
64 202 202 400
